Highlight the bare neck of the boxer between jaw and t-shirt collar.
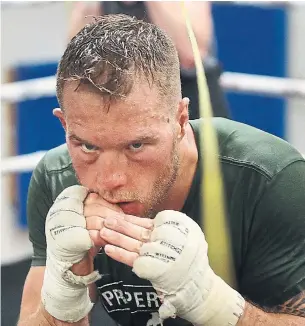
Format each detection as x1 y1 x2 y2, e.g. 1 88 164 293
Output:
162 124 198 211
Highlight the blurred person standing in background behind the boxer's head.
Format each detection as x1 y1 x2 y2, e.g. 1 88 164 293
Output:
68 1 230 119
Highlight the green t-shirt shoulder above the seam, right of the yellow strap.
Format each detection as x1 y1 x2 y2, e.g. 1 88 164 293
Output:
191 118 305 179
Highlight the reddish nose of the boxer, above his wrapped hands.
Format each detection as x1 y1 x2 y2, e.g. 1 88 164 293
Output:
97 152 127 191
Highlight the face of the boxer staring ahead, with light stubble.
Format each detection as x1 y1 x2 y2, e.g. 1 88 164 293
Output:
56 83 187 217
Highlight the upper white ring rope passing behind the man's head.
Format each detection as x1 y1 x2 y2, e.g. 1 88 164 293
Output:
1 72 305 103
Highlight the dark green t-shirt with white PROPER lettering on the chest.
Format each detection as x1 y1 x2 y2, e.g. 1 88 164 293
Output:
28 118 305 326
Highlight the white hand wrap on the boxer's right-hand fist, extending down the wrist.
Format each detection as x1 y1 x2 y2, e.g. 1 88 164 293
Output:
133 211 245 326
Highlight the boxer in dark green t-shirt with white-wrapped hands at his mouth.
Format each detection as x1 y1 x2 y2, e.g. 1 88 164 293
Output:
18 15 305 326
